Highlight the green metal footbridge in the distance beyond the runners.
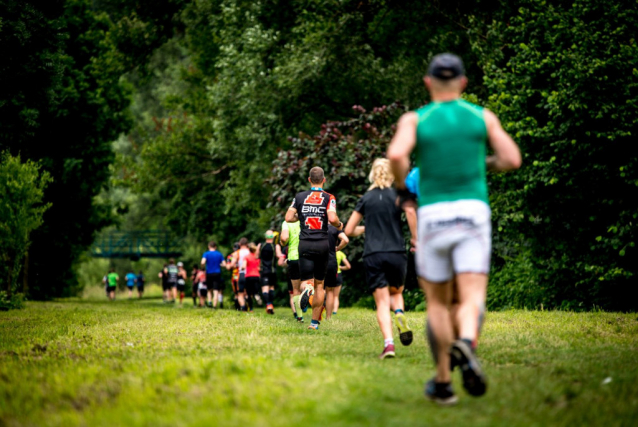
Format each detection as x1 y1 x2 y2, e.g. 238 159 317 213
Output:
91 230 182 260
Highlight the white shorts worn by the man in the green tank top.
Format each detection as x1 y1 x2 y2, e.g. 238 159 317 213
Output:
416 200 492 283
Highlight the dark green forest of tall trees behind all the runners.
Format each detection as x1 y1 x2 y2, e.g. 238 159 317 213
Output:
0 0 638 310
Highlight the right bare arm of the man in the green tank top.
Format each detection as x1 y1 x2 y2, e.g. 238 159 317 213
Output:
484 110 522 171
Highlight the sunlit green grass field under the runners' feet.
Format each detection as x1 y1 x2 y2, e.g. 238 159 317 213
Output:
0 291 638 427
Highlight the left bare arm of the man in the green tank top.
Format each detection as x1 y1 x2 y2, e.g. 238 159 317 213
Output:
387 112 418 190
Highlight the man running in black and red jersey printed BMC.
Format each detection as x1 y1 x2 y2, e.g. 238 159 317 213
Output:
286 167 343 329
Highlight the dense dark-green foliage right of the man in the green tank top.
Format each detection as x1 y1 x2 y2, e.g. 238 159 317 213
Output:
475 0 638 309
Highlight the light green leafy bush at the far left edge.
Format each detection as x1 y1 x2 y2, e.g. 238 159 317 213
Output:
0 152 51 299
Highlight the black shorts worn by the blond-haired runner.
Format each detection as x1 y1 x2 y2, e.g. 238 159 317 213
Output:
363 252 408 292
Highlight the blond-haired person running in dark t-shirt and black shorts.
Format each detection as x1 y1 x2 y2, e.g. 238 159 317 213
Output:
346 159 413 359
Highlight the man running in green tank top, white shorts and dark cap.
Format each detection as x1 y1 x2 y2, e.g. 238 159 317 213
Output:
387 53 521 405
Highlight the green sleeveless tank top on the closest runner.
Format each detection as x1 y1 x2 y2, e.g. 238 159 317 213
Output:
416 99 489 206
